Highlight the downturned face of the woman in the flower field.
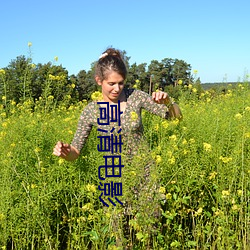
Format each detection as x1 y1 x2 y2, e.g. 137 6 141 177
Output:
96 71 124 102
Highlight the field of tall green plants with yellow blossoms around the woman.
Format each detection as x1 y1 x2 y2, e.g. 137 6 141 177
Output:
0 83 250 250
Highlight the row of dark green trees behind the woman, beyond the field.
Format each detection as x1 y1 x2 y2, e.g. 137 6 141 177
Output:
0 51 199 103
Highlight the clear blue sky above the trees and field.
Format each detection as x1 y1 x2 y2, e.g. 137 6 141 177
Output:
0 0 250 83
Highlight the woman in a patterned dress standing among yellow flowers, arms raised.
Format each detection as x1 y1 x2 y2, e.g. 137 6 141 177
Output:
53 48 182 245
